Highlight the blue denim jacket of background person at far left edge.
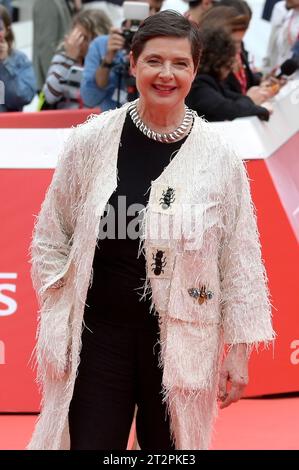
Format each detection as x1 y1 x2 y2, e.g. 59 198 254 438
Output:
0 50 36 112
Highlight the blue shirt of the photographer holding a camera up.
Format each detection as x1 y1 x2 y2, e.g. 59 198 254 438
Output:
81 35 127 111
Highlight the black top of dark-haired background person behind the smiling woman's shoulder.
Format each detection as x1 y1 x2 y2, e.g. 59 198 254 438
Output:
186 74 269 121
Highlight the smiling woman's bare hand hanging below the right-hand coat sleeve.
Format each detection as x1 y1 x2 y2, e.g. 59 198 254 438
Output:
218 344 249 409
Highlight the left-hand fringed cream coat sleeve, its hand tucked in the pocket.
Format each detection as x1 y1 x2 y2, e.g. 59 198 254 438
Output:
31 129 80 299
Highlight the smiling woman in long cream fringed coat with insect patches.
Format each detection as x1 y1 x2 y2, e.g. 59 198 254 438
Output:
29 11 273 450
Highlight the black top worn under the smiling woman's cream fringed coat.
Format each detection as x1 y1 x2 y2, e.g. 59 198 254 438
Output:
84 115 186 327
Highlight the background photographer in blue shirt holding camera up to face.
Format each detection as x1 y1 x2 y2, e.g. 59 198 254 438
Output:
81 0 162 111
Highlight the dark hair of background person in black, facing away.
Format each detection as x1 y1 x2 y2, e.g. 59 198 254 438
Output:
199 28 236 80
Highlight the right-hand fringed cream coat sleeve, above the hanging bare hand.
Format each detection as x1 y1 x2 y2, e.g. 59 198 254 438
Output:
220 154 275 346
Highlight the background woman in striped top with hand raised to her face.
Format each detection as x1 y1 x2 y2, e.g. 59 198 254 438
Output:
42 10 111 109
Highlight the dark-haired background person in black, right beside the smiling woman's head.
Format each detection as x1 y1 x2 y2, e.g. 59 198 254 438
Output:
186 27 269 121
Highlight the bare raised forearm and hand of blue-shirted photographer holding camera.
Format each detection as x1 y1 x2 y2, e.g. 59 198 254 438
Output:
95 28 124 88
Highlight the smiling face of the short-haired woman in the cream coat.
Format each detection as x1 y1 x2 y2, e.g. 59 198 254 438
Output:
130 37 196 107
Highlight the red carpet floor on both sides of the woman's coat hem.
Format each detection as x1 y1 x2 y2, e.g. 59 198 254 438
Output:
0 398 299 450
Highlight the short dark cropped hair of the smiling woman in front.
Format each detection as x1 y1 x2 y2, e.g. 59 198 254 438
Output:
132 10 202 69
